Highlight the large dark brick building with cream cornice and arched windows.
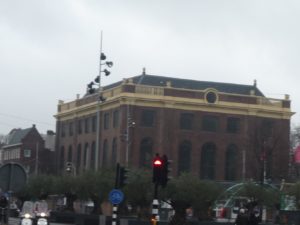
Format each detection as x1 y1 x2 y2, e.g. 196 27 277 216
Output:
56 73 293 180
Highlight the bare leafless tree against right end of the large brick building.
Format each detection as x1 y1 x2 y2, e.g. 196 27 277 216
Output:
249 118 289 183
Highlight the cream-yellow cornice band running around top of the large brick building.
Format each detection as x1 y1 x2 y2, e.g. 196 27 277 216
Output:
55 83 294 121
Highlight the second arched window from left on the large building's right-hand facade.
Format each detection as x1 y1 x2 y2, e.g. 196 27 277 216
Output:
178 141 192 175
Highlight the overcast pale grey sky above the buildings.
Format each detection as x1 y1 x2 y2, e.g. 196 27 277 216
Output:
0 0 300 134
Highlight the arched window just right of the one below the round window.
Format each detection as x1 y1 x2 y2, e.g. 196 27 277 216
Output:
225 144 238 180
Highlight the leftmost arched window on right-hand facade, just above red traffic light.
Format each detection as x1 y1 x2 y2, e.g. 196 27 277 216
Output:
140 138 153 168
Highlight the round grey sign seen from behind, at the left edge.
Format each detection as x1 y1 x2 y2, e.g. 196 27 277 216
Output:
0 163 27 192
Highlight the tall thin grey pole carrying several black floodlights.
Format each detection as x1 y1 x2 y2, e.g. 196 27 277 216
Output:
87 31 113 171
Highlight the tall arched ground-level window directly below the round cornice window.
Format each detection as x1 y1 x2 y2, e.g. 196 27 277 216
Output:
200 142 216 180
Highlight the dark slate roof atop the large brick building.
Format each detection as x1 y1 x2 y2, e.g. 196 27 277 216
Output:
85 74 264 96
